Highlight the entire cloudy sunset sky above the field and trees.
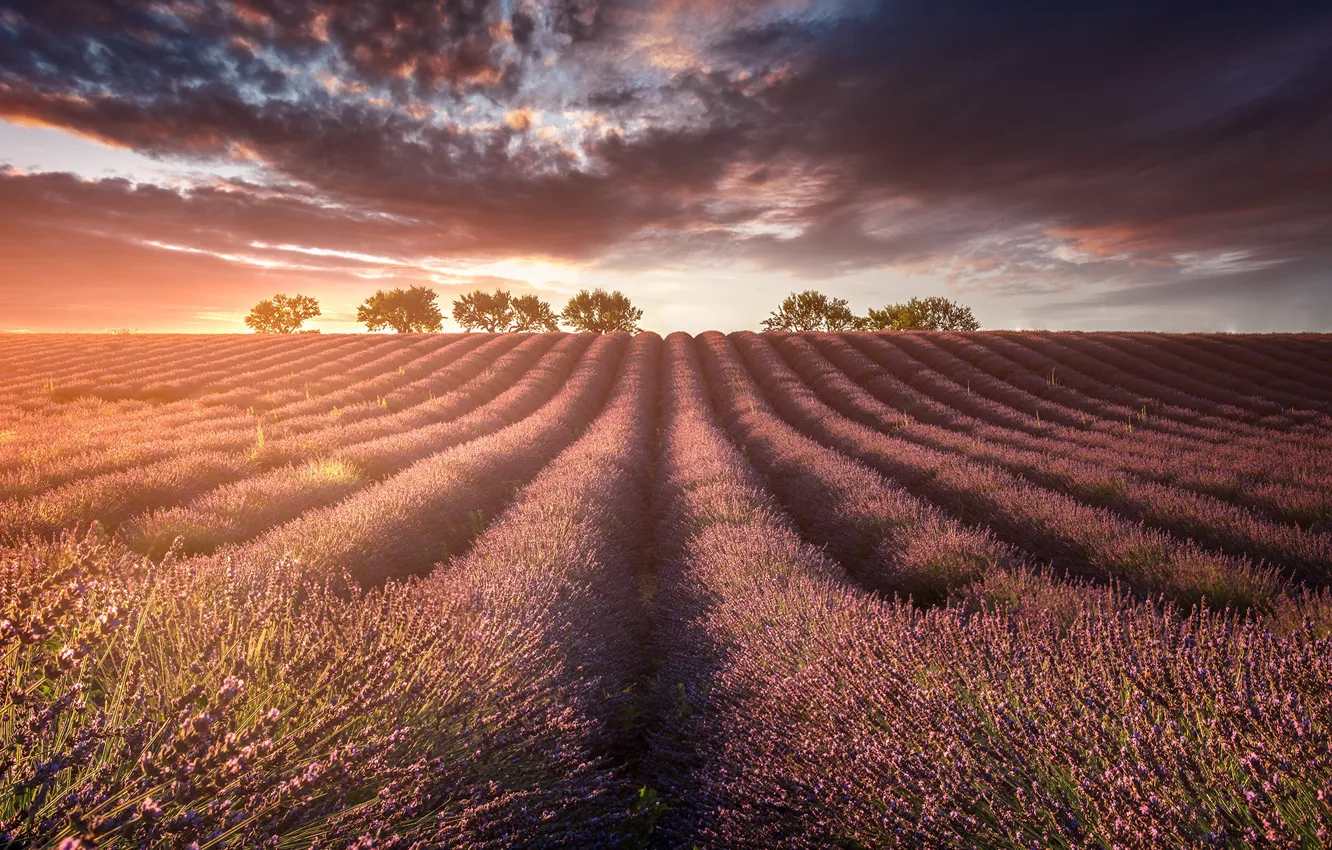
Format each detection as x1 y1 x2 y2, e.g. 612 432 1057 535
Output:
0 0 1332 332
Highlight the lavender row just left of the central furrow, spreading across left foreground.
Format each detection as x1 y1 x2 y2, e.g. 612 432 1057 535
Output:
0 337 661 849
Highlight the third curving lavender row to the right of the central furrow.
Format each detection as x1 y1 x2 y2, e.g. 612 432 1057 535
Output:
701 333 1284 608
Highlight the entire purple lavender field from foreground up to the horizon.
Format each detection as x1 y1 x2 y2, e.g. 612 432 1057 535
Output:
0 332 1332 850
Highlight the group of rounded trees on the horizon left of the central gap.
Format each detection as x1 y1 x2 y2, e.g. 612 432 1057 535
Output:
245 286 643 333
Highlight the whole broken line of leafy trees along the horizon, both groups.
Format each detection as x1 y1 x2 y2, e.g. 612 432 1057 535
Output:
245 286 980 333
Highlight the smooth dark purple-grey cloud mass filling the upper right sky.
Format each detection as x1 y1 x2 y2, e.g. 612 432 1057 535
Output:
723 0 1332 273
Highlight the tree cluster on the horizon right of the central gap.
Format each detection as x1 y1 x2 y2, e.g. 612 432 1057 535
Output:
763 289 980 332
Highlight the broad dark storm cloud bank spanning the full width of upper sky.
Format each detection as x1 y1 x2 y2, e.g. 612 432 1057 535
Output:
0 0 1332 317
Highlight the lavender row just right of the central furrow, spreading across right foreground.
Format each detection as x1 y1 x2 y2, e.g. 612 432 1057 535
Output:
645 337 1332 847
